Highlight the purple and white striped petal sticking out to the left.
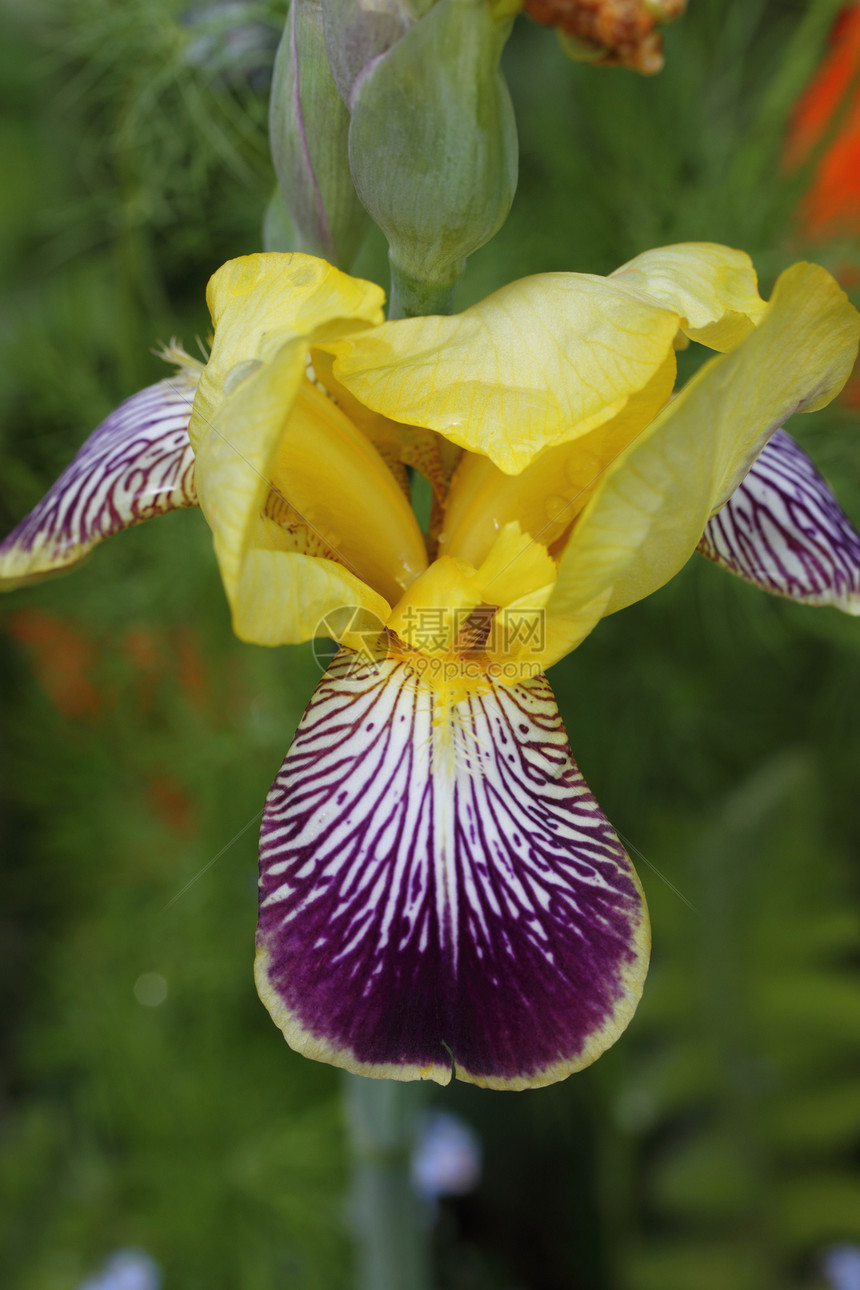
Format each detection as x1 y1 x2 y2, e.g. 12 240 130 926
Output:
0 359 201 590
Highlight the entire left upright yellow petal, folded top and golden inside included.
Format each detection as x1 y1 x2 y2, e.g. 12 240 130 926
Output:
191 254 427 645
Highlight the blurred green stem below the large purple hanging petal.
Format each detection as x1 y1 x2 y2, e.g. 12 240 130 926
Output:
343 1075 431 1290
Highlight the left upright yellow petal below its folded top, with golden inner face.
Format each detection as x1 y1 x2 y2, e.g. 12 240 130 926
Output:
196 338 427 645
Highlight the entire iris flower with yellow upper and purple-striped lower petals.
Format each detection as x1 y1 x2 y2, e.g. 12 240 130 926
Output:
0 244 860 1089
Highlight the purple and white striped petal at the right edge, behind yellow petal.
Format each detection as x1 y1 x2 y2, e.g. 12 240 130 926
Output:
699 430 860 614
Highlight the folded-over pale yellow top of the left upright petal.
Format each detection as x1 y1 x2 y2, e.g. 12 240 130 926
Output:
191 252 386 448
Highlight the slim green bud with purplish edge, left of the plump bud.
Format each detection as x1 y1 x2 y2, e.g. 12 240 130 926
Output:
269 0 367 268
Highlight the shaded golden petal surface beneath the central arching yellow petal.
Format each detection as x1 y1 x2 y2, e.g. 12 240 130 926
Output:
440 351 676 564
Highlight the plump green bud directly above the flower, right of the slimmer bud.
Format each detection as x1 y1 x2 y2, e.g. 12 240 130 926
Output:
349 0 517 299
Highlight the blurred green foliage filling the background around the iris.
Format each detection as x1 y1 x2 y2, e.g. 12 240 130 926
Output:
0 0 860 1290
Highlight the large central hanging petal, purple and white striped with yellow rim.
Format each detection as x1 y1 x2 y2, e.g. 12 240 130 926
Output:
257 651 650 1089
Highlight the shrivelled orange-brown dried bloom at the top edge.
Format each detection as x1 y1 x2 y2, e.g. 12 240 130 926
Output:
525 0 686 76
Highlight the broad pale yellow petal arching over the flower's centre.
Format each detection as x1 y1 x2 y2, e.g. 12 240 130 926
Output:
325 273 678 473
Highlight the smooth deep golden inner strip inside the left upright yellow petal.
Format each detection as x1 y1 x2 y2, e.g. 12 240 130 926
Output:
272 379 427 604
